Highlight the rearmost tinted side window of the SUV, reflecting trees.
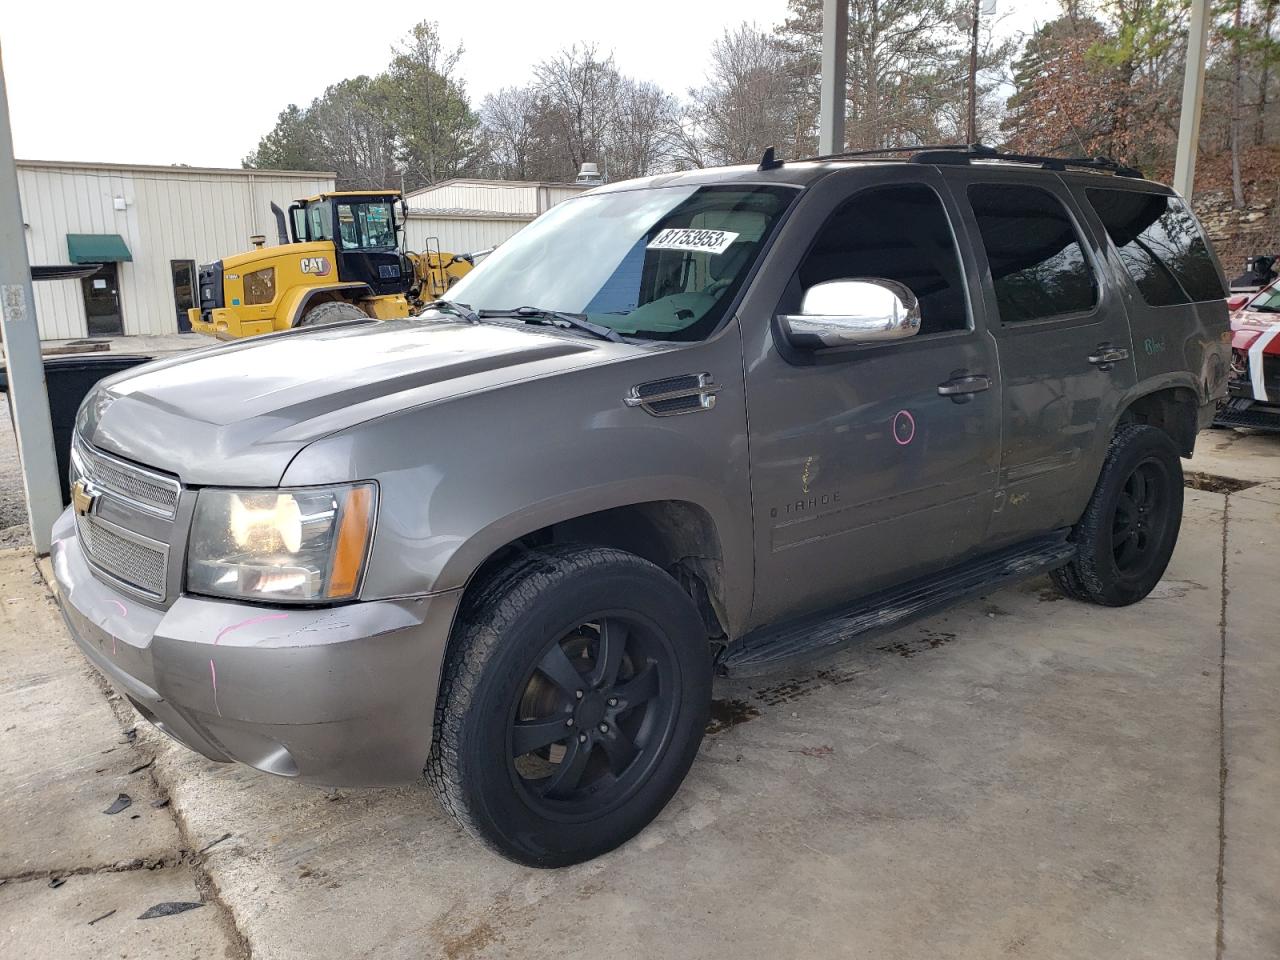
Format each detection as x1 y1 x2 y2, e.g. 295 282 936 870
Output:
1085 189 1226 307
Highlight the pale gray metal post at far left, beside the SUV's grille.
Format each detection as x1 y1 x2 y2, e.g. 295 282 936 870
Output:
0 43 63 553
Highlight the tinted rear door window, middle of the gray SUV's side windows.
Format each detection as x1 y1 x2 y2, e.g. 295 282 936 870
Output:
969 183 1098 324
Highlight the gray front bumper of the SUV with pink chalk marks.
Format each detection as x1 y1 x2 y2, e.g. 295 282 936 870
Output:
52 511 461 785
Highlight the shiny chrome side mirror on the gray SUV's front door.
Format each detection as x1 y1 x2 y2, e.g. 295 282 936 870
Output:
778 278 920 349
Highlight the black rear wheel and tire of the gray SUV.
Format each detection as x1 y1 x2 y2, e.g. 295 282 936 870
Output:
1052 424 1183 607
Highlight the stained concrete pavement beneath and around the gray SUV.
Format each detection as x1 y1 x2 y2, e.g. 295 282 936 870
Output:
0 455 1280 960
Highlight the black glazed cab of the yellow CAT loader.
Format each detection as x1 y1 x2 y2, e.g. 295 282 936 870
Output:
289 191 412 294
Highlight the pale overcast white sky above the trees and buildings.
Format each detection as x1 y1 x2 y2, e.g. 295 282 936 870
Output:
0 0 1057 166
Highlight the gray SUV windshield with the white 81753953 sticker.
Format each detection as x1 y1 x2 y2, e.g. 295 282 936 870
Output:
448 186 797 340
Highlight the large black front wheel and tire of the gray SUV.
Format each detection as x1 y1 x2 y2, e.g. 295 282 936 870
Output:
426 547 712 867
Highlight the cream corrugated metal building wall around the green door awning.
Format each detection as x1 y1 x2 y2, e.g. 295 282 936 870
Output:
18 160 333 339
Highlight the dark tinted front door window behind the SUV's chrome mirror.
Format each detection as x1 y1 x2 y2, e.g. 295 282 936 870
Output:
799 183 969 337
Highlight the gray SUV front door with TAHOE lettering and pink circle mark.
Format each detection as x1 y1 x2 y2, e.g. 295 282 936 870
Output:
742 168 1001 626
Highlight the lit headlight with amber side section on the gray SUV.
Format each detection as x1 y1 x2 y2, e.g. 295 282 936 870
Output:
187 484 376 603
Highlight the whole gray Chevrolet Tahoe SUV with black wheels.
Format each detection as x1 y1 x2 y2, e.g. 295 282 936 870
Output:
54 150 1229 867
